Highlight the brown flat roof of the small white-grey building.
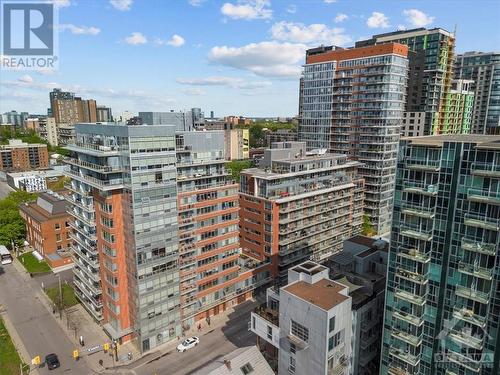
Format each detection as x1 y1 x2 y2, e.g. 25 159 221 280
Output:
283 279 349 311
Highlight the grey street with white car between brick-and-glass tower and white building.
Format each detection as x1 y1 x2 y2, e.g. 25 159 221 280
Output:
133 306 255 375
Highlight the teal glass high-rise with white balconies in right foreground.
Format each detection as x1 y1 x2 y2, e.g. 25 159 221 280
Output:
381 135 500 375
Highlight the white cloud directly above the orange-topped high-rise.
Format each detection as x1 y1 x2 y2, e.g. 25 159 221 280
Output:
271 21 351 45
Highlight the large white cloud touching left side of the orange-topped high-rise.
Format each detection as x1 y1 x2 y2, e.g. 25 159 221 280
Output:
208 42 307 78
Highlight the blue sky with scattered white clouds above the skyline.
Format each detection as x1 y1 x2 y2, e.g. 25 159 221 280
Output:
0 0 500 117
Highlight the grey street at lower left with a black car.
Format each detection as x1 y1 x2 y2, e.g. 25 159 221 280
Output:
0 264 92 375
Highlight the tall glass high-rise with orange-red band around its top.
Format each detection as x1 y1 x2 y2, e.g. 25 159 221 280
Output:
299 43 408 234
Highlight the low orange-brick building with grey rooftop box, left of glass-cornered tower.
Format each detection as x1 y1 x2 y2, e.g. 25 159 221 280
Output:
19 192 73 268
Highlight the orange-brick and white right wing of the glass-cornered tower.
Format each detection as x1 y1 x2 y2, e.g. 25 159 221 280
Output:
176 131 270 328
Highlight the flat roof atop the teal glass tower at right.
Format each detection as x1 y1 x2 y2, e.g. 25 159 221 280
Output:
401 134 500 148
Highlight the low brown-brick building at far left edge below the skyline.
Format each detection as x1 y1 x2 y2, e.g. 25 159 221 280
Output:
0 139 49 172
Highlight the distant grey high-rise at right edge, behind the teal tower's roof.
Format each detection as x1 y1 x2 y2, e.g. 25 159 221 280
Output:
454 51 500 134
